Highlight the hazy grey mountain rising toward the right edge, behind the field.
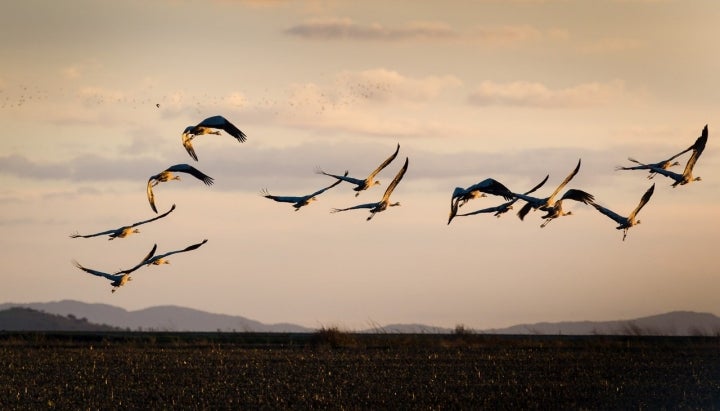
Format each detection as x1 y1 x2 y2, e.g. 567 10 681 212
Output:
485 311 720 336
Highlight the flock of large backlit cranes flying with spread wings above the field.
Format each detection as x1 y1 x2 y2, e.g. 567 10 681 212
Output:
70 115 708 292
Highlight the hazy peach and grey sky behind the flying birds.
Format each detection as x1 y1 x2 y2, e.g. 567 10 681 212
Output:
0 0 720 330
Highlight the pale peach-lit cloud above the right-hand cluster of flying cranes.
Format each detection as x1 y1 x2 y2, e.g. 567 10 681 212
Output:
468 80 625 108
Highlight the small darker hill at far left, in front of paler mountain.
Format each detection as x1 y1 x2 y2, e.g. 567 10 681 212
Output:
0 307 118 331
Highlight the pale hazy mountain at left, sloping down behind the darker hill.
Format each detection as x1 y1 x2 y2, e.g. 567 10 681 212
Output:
0 300 313 332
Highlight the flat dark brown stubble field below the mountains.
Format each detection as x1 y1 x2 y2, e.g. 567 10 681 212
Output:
0 330 720 410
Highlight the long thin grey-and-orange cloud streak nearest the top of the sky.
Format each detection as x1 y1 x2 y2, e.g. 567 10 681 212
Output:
285 19 566 44
